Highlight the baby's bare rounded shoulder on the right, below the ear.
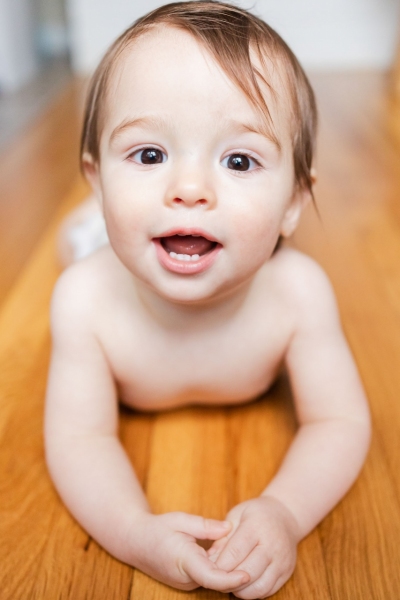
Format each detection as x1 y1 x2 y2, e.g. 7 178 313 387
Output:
271 248 339 327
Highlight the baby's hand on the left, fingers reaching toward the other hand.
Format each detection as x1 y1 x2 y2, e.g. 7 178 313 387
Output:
129 512 249 592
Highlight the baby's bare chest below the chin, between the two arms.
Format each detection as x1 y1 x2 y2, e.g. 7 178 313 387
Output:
90 246 291 410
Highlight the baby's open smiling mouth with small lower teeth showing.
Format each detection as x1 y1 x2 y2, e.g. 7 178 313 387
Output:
153 233 222 274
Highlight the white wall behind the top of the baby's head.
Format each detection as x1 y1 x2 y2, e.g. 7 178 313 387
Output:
68 0 400 73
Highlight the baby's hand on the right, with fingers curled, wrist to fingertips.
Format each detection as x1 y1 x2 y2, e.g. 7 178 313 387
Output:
208 496 299 599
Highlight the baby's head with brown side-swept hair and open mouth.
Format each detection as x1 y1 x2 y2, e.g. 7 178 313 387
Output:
82 1 316 302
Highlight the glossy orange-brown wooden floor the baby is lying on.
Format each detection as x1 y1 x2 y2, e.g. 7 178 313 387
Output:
0 73 400 600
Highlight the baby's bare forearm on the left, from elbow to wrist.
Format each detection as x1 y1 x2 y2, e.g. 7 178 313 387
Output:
46 435 150 563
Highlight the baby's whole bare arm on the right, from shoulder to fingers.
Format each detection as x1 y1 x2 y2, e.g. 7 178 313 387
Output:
209 259 370 598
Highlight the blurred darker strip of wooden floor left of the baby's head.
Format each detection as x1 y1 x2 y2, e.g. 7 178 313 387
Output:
0 81 84 304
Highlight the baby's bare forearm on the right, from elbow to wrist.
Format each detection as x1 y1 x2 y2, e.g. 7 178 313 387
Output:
262 419 370 539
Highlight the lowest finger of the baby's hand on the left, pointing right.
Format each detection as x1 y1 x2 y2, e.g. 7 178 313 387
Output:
182 553 250 593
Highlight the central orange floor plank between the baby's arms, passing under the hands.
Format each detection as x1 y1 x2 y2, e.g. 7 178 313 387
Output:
130 408 227 600
